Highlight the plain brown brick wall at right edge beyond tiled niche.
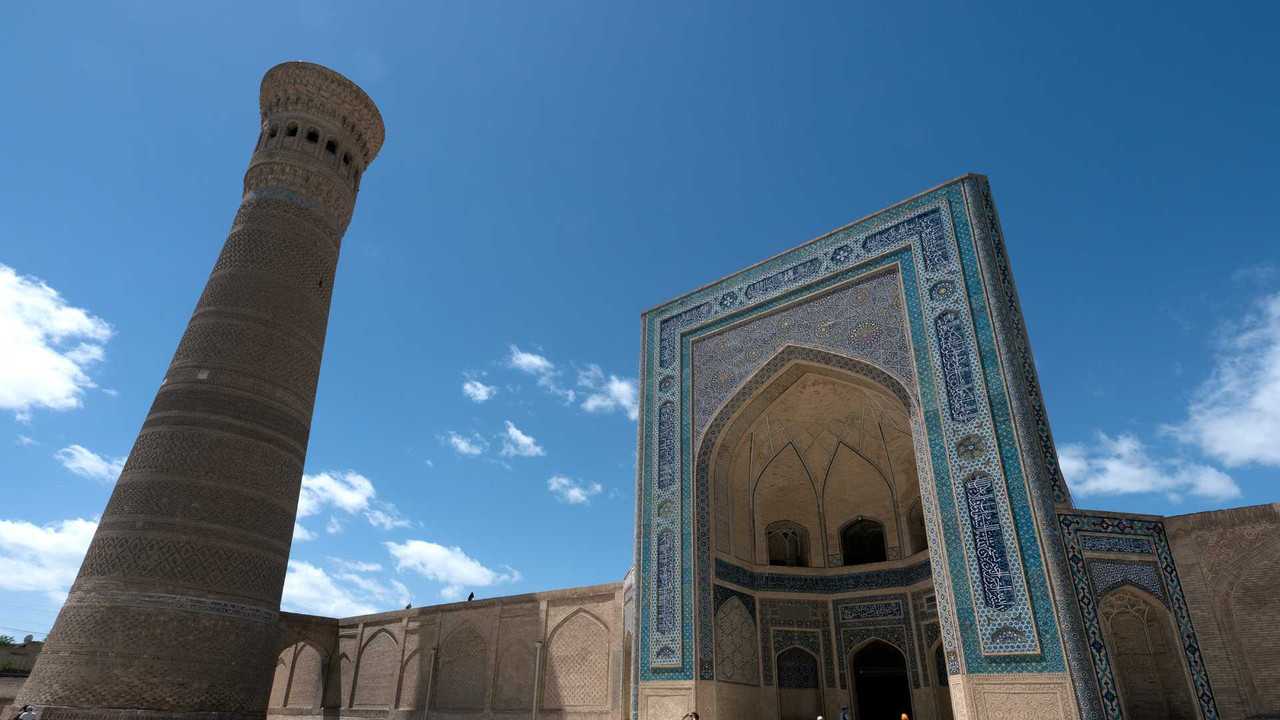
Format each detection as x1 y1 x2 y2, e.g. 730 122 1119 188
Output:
1165 503 1280 720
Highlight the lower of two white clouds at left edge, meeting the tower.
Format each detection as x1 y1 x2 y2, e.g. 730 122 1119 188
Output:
0 519 97 603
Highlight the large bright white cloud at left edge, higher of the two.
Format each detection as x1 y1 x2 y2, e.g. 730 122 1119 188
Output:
0 265 111 421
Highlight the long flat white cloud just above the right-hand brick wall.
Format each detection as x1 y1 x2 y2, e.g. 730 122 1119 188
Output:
1059 433 1240 501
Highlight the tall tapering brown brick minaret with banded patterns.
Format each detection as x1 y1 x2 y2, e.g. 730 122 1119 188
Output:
18 63 383 720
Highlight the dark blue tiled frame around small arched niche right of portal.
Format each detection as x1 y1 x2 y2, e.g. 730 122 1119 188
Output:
1059 512 1219 720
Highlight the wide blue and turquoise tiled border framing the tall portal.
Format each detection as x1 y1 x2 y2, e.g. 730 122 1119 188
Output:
639 181 1062 680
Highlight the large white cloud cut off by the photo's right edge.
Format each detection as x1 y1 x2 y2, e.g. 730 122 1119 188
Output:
1166 293 1280 468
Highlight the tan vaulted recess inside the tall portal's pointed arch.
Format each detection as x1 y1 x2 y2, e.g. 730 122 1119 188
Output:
695 345 950 720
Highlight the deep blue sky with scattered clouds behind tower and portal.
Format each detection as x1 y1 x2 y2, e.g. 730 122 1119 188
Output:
0 3 1280 634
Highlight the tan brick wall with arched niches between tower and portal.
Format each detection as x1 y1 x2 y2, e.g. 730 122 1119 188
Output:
268 583 625 720
